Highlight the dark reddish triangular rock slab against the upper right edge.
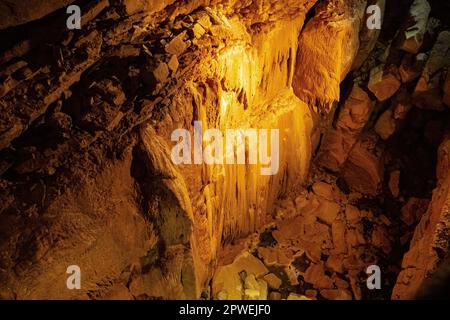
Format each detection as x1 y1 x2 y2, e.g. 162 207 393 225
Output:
413 31 450 110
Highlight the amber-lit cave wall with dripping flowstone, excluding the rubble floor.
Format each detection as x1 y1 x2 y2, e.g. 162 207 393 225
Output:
0 0 449 299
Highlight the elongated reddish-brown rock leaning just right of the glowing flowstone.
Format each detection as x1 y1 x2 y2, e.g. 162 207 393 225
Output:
318 85 373 171
